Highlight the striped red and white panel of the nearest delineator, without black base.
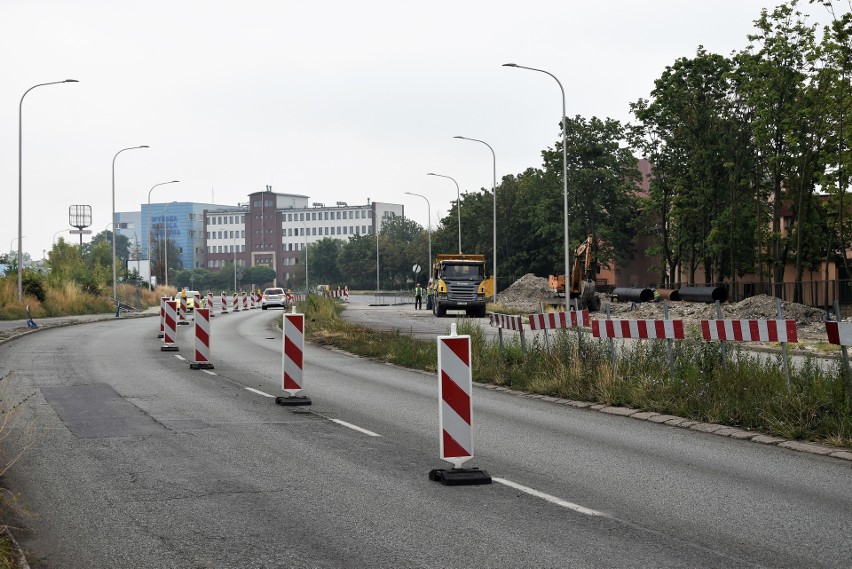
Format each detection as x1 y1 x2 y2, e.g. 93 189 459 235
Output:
438 328 473 468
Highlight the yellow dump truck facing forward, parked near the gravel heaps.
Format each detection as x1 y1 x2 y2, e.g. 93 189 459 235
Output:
428 253 494 318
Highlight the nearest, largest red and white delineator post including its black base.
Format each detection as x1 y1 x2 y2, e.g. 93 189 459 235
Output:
429 324 491 486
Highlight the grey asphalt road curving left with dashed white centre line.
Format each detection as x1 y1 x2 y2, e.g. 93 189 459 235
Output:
0 310 852 569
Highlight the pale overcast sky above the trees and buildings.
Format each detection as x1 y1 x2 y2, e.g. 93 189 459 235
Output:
0 0 840 259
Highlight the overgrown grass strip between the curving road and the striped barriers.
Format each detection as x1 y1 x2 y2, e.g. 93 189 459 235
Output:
304 296 852 447
